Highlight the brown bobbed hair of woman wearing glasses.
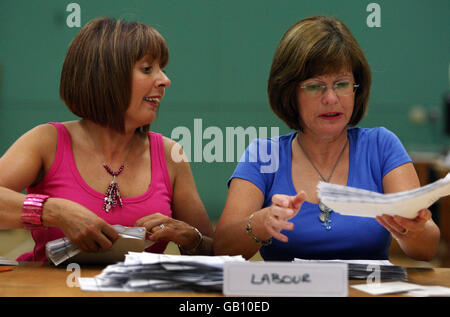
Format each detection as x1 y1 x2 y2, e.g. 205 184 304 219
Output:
268 16 372 131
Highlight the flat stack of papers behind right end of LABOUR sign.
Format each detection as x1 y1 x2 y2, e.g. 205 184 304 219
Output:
294 259 408 281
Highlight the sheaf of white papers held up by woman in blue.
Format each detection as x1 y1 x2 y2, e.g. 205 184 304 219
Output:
317 173 450 219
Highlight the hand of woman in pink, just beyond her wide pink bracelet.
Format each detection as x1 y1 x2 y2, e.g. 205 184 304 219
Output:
42 198 118 252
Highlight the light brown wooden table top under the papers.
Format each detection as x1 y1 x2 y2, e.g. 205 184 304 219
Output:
0 262 450 297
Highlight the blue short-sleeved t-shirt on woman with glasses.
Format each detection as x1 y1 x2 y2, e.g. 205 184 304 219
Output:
228 127 411 261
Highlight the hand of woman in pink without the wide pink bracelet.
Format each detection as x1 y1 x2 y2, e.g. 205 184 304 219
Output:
135 213 199 250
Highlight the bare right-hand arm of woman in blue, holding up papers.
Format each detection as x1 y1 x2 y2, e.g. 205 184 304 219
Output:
377 163 440 261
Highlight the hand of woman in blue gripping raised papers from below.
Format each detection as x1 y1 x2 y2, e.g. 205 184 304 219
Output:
377 209 431 240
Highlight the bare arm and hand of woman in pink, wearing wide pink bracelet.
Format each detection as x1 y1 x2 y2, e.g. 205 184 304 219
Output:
0 125 117 251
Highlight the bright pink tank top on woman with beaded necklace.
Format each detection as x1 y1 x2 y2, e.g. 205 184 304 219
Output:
17 122 173 261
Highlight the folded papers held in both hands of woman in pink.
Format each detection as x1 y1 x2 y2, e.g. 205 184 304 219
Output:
45 225 153 266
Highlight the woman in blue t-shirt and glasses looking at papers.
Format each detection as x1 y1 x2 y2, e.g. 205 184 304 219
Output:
214 16 440 261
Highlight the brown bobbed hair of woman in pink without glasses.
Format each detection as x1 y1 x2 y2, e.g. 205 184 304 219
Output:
59 18 169 132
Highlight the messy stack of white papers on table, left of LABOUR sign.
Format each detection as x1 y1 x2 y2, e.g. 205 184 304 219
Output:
78 252 245 292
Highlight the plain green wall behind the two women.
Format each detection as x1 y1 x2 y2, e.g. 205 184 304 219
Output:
0 0 450 220
